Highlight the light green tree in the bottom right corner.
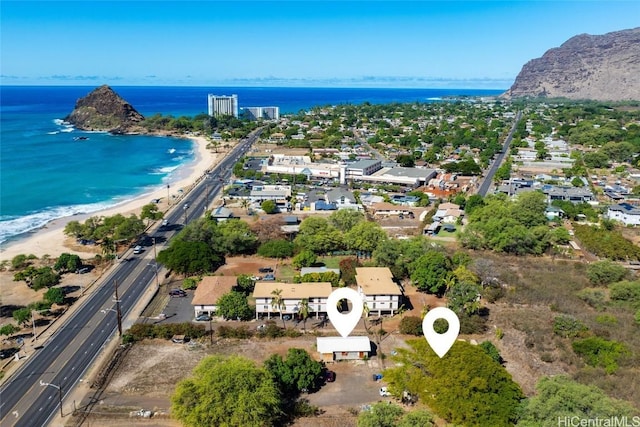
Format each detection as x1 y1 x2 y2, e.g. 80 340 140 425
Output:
518 375 637 427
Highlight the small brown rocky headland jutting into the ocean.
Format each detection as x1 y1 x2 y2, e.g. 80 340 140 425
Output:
64 85 144 133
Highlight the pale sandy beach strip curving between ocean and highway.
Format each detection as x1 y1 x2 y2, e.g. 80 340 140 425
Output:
0 136 226 260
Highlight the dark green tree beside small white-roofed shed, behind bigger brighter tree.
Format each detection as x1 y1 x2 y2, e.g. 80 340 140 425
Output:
264 348 322 398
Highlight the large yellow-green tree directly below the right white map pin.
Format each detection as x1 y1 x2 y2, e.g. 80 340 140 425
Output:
383 339 524 427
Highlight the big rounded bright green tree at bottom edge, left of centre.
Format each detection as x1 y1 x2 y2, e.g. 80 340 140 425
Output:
171 356 281 427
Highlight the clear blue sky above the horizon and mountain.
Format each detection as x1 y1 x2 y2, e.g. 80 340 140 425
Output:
0 0 640 89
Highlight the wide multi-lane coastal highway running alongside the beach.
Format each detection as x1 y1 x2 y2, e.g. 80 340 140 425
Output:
0 129 261 427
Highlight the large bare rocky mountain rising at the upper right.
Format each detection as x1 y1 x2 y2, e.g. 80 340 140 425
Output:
503 27 640 101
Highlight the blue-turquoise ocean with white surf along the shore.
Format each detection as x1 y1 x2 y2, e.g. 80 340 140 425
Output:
0 86 503 244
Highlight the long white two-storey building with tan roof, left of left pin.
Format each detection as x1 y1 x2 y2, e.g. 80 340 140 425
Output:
253 282 332 319
